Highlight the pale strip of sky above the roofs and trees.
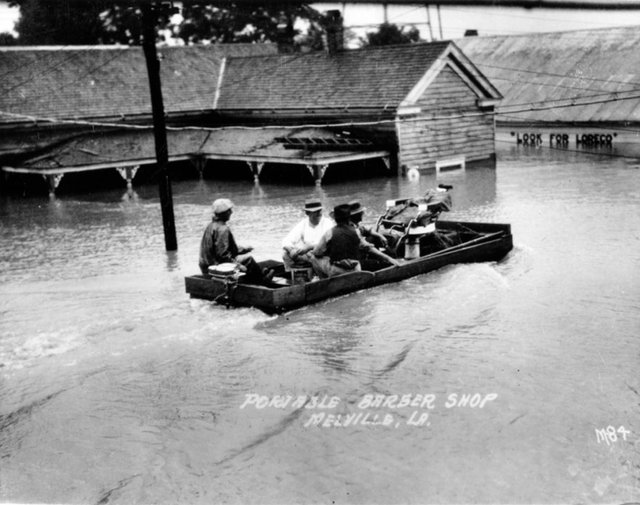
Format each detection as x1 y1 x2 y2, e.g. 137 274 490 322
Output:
0 0 640 40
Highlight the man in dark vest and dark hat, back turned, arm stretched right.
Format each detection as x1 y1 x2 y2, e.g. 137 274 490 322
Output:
313 204 399 277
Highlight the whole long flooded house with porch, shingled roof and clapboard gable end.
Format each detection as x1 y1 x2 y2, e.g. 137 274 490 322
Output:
0 36 501 191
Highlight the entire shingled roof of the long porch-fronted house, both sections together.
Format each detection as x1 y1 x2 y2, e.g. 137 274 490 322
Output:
0 41 498 128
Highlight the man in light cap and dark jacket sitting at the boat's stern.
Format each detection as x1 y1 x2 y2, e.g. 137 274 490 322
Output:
199 198 273 285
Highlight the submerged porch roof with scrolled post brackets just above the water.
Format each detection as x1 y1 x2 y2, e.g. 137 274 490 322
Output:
2 127 392 196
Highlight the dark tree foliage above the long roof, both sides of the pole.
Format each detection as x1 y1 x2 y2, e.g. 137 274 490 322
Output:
10 0 321 48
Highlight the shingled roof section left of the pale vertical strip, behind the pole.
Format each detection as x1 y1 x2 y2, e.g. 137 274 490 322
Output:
0 44 277 124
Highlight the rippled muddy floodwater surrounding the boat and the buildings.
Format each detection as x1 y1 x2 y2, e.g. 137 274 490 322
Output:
0 145 640 504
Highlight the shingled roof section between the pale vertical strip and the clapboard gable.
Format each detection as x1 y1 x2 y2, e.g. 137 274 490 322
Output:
216 41 497 110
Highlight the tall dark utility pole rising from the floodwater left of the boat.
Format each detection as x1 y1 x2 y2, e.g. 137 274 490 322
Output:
141 4 178 251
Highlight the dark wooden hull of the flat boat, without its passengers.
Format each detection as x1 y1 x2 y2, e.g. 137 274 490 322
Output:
185 221 513 313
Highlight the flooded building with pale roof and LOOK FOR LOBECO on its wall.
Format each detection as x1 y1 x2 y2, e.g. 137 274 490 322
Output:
456 26 640 157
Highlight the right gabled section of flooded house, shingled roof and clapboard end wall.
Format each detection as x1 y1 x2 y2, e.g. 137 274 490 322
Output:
216 41 501 169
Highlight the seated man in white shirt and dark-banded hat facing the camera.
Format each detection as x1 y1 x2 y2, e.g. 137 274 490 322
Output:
282 200 334 271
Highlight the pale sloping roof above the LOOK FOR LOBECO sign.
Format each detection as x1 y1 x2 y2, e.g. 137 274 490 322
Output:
456 26 640 122
